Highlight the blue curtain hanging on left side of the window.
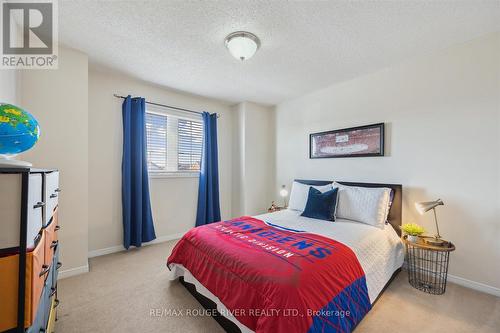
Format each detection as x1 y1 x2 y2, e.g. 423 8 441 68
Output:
122 95 156 249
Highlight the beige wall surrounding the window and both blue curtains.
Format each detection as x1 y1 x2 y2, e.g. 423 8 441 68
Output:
88 68 233 253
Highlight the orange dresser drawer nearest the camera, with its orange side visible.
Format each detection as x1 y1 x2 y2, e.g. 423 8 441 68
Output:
0 234 47 332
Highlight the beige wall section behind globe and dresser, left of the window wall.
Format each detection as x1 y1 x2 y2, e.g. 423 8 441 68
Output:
20 47 89 272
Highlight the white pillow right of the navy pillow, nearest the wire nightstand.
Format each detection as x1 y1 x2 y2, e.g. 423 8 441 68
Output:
333 182 391 228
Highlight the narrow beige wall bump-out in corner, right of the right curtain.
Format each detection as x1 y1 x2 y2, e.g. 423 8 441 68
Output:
233 102 275 216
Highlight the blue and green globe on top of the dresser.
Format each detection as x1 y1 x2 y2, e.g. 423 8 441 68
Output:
0 104 40 158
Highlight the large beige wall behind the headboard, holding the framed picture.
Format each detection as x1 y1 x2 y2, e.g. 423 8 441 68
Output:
276 33 500 288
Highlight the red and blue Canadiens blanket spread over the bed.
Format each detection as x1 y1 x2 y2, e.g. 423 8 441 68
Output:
167 217 371 333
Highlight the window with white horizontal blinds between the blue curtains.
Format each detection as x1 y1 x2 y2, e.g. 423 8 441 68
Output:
146 105 203 177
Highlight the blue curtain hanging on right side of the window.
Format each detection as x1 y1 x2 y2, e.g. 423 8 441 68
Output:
196 112 221 226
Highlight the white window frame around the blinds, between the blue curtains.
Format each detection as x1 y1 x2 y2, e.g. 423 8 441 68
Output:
146 104 203 179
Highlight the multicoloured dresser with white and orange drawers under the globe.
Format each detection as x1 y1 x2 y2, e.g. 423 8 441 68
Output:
0 168 61 333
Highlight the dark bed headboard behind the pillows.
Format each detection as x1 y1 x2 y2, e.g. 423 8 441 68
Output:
295 179 403 236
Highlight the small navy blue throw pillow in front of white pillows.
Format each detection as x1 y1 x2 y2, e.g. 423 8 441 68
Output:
301 186 339 221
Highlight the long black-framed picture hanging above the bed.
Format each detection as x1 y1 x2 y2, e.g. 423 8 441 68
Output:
309 123 384 158
